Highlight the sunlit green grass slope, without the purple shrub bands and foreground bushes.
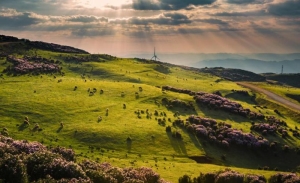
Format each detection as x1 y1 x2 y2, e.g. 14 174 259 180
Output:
0 35 300 182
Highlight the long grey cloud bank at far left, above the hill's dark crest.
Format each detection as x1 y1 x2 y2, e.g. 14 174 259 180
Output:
0 9 112 32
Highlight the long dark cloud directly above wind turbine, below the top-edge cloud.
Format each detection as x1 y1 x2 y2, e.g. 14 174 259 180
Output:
111 13 192 25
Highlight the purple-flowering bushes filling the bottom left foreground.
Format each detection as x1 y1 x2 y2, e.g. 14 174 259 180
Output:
0 136 165 183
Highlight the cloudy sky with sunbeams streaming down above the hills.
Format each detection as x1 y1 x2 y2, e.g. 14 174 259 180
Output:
0 0 300 56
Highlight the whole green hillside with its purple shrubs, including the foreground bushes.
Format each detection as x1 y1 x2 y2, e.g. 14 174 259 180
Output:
0 36 300 182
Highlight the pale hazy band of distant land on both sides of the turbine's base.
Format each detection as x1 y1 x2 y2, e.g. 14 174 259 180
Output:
128 53 300 74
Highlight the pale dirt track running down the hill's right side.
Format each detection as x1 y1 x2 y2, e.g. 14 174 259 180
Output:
237 82 300 112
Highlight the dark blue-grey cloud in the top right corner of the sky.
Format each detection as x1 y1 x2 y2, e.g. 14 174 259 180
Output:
267 0 300 16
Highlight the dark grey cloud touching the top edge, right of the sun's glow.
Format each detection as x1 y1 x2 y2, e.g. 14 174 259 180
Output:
131 0 216 10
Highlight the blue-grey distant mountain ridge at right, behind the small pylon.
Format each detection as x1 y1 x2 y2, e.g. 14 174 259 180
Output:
191 59 300 73
